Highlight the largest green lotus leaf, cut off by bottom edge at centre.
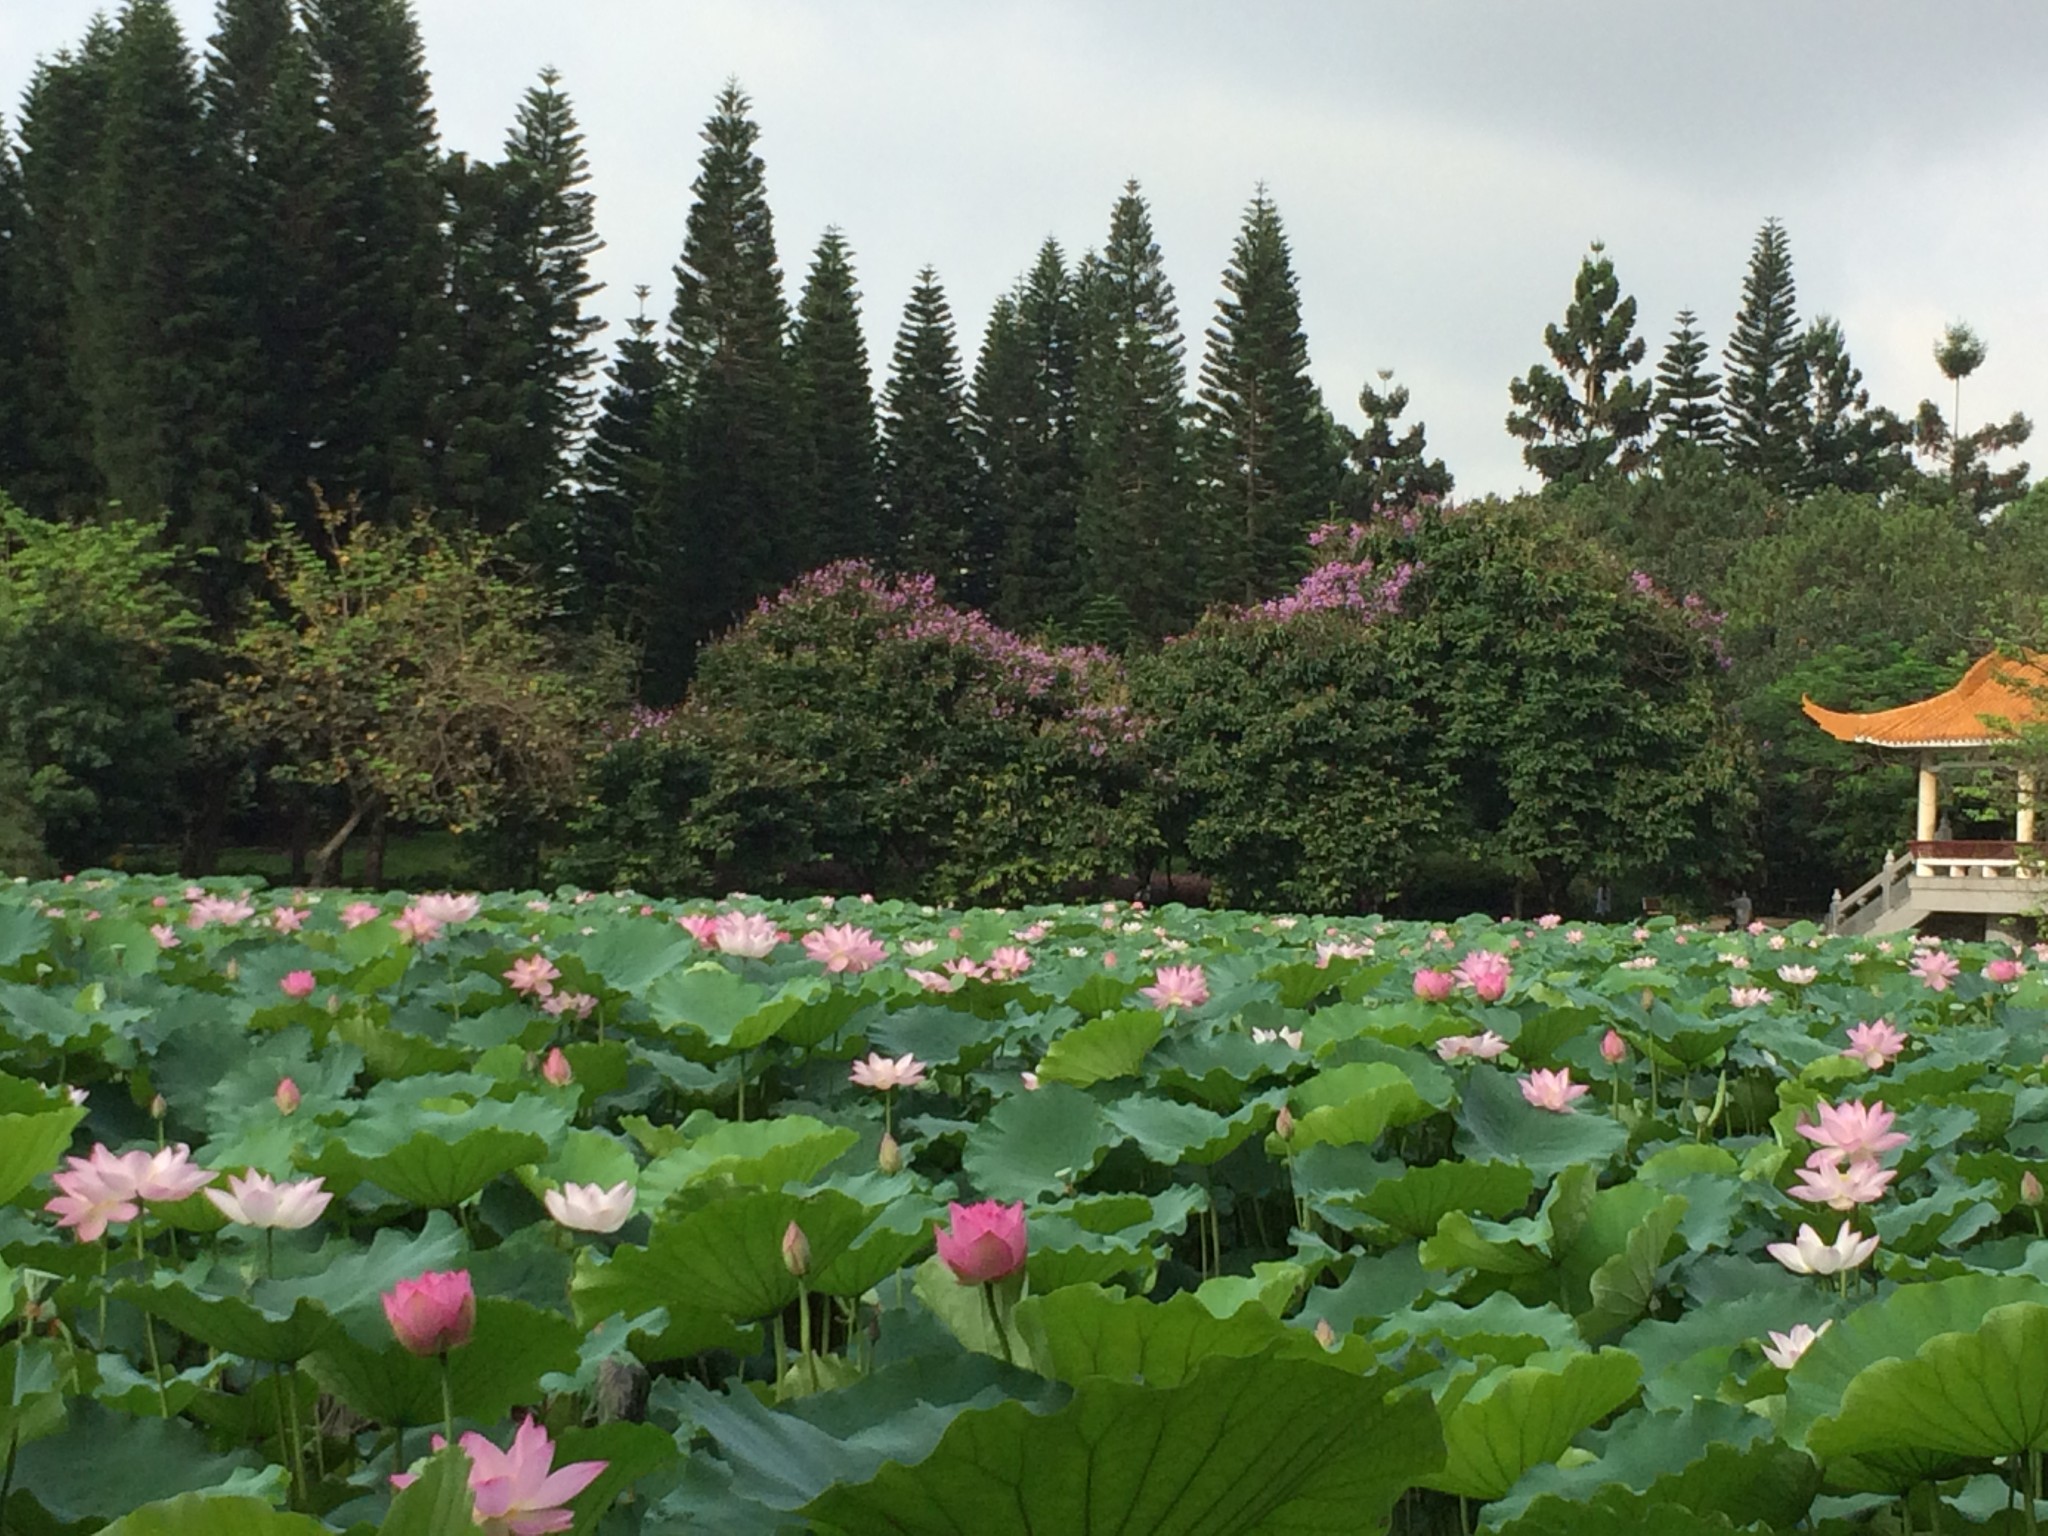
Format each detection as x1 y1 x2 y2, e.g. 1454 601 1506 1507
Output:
803 1358 1442 1536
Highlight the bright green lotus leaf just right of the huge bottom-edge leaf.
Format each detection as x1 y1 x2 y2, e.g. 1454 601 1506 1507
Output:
1421 1348 1642 1499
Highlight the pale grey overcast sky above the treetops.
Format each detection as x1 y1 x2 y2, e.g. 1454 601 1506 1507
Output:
0 0 2048 494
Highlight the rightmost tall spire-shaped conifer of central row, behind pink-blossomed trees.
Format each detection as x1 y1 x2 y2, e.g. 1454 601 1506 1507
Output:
1200 186 1341 602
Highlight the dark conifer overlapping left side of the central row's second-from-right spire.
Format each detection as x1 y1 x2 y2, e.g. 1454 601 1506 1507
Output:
973 240 1081 631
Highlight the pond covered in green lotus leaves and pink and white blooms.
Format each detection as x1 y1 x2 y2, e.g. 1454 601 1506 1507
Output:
0 877 2048 1536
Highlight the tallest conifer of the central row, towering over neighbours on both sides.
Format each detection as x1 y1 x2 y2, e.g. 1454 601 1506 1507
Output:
647 84 811 696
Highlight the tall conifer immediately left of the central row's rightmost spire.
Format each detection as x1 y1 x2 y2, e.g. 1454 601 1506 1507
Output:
1075 182 1200 641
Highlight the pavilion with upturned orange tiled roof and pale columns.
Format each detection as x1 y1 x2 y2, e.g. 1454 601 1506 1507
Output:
1802 651 2048 934
